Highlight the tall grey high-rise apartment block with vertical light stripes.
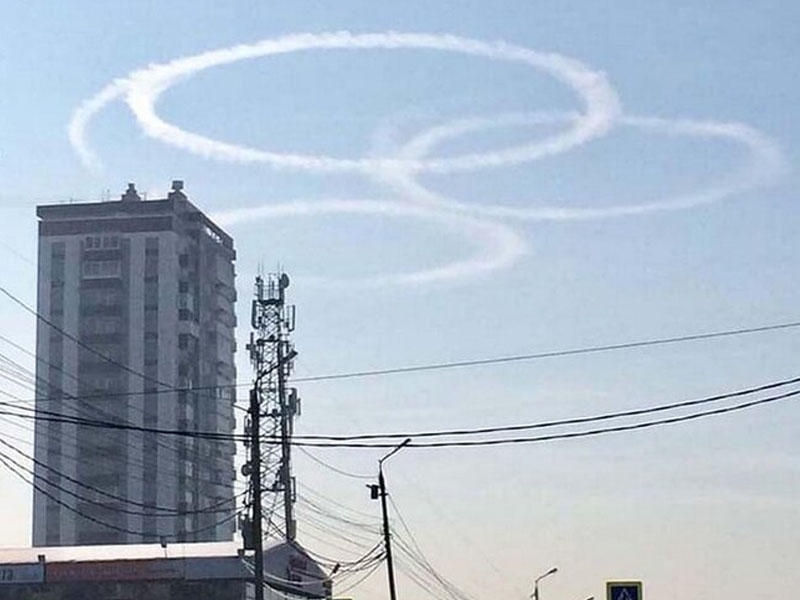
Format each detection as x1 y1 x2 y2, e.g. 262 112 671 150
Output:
33 181 236 546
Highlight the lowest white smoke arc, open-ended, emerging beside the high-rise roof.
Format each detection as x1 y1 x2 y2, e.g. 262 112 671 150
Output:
211 199 527 288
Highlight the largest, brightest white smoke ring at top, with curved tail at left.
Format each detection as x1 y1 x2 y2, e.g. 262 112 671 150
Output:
70 31 620 173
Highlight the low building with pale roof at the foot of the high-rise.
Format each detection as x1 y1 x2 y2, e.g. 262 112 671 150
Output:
0 542 330 600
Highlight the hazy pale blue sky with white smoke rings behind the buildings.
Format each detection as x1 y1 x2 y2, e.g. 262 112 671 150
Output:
0 0 800 600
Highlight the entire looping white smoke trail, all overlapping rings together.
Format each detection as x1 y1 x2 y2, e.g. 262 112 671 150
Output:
64 32 785 286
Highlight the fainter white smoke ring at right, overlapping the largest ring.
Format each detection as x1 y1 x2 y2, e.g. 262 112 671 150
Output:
382 112 786 220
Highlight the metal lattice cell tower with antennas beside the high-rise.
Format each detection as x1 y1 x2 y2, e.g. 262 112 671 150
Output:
242 273 300 600
